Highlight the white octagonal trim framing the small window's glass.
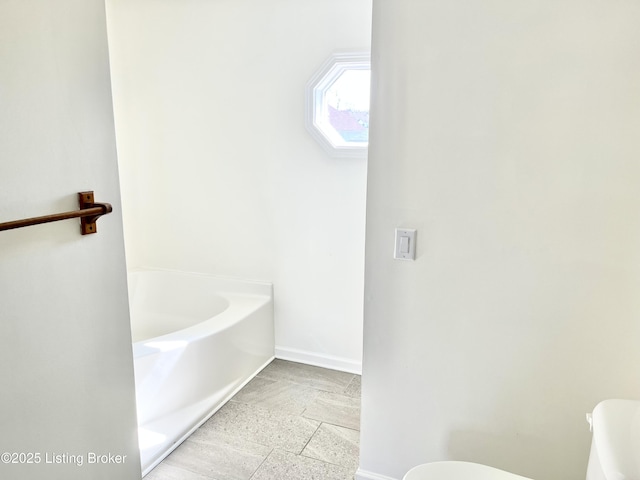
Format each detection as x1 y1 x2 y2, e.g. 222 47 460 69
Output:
305 52 371 158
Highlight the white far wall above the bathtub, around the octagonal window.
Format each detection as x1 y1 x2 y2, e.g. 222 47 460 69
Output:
107 0 371 370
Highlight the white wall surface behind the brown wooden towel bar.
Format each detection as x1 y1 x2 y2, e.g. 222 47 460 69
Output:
0 0 140 480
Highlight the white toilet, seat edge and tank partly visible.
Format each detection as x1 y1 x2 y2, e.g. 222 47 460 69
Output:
403 400 640 480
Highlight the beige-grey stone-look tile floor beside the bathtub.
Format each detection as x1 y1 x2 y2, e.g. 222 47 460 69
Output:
145 360 360 480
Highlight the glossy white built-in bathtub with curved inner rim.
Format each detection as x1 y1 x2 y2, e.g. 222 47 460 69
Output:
129 270 274 475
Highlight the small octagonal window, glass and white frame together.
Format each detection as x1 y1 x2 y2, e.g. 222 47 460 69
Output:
307 54 371 157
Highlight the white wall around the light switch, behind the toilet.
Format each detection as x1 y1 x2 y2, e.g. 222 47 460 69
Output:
358 0 640 480
